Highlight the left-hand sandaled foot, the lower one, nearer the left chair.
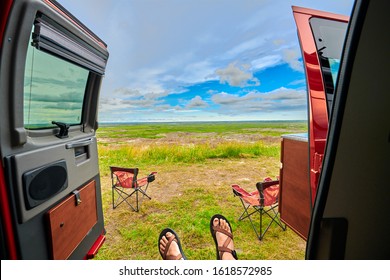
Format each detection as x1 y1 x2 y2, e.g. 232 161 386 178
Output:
159 230 185 260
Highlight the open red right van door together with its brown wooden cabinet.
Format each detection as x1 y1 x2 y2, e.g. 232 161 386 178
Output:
279 7 349 239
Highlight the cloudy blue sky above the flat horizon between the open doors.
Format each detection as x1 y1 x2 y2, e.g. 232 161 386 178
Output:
58 0 353 122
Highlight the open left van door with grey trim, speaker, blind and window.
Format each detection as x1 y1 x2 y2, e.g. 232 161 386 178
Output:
0 0 108 259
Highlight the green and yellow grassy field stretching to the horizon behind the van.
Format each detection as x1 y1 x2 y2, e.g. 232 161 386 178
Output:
93 122 307 260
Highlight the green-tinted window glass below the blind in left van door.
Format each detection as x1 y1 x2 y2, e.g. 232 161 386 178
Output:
24 38 89 129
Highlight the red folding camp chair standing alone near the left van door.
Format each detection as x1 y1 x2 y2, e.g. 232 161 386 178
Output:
110 166 157 212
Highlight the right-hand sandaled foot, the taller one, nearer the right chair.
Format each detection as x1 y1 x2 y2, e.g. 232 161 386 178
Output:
212 215 237 260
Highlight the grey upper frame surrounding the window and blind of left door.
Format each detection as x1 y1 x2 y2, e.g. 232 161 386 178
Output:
0 1 109 149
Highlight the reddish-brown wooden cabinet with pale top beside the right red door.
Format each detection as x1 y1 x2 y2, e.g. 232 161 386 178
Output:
279 134 311 240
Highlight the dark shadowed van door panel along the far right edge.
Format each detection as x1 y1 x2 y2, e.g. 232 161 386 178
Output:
306 0 390 259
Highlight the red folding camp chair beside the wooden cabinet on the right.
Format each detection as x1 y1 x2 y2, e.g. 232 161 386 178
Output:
232 178 286 240
